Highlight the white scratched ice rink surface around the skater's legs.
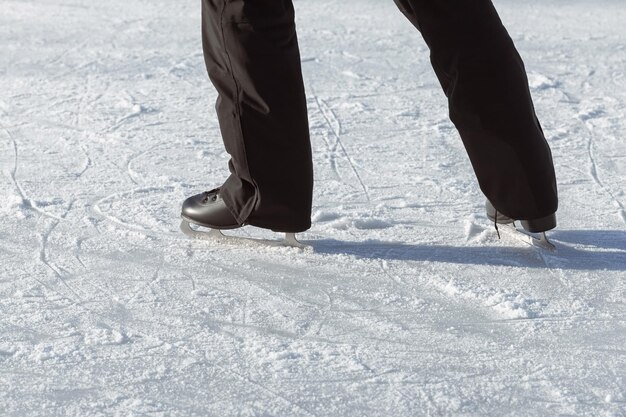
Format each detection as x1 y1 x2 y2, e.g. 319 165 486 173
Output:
0 0 626 417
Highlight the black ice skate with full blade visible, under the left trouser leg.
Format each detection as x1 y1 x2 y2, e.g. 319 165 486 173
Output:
180 188 306 248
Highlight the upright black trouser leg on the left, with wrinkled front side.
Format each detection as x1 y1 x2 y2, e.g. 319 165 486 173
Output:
202 0 313 232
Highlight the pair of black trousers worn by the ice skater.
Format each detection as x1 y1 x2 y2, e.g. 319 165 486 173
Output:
202 0 557 232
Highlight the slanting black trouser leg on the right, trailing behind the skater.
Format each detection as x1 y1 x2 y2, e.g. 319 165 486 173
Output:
394 0 557 219
